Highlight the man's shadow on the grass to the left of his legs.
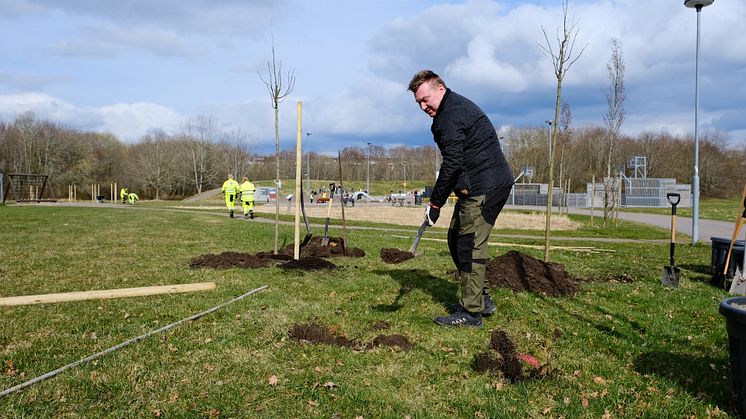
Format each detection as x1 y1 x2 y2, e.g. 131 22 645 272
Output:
373 269 458 312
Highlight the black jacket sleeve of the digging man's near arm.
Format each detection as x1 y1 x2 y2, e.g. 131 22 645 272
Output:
430 122 465 207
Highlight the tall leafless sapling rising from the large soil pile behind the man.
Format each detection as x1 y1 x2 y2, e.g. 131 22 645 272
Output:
539 0 587 262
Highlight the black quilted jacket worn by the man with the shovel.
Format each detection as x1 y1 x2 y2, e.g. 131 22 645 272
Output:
430 89 513 206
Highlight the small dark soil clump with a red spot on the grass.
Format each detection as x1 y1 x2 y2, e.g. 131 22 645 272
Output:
474 329 547 383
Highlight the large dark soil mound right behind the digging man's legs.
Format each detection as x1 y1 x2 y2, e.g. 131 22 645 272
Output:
486 250 578 297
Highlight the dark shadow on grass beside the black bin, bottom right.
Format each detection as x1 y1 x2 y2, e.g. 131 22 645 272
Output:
634 351 736 415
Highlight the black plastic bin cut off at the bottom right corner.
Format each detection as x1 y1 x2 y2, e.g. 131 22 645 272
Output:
720 297 746 417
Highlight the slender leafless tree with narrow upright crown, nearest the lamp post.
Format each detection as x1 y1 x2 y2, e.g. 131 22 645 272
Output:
604 39 625 226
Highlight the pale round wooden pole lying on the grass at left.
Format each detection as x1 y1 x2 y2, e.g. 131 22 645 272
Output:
0 282 215 306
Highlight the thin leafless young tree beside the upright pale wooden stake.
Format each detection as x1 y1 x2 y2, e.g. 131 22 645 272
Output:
259 38 295 254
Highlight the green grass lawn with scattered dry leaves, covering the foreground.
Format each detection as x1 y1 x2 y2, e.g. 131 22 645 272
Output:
0 205 735 418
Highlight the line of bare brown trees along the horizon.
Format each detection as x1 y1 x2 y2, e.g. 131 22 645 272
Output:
0 111 746 199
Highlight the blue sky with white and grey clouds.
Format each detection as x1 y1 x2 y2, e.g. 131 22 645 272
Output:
0 0 746 155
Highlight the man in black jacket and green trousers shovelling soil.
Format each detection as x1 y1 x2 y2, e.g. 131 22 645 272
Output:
409 70 513 327
